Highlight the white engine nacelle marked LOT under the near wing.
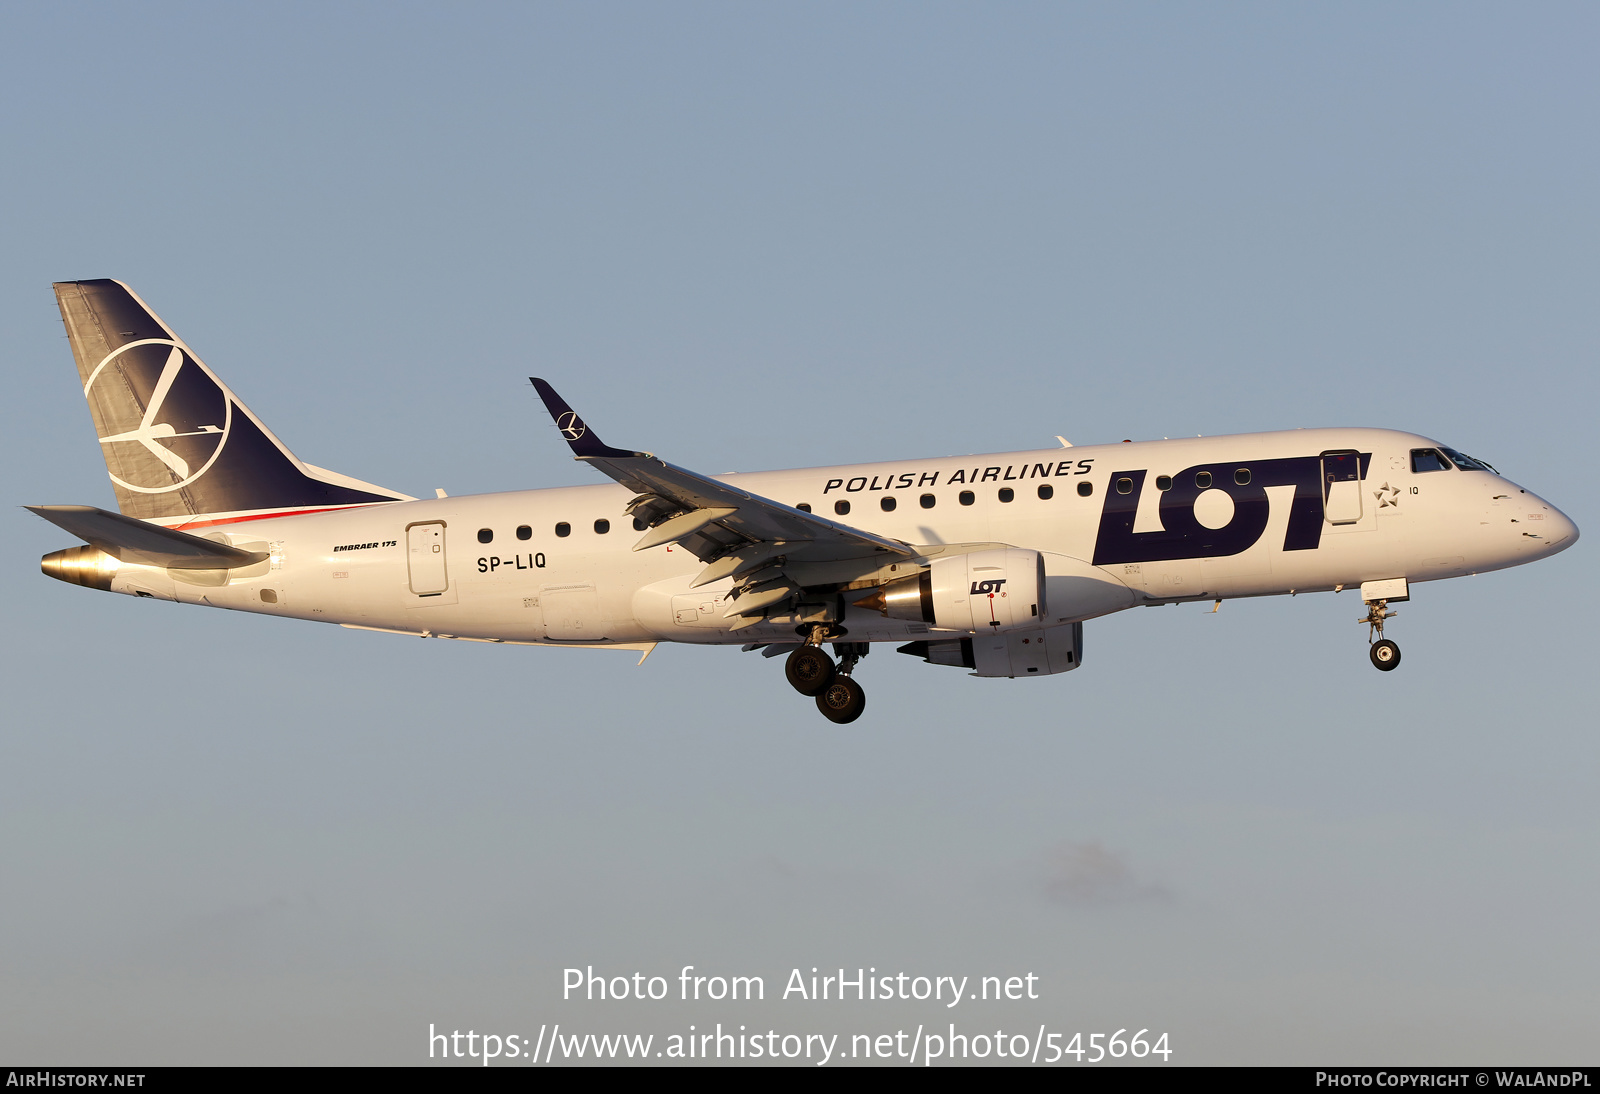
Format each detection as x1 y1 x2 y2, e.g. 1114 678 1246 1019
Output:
856 547 1048 635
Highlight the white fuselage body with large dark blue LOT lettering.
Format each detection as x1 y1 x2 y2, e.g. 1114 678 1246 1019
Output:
100 429 1578 646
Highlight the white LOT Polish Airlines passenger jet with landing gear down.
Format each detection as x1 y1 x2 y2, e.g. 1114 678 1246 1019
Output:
29 280 1578 723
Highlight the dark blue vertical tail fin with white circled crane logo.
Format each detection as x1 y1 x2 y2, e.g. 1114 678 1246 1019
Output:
54 280 411 520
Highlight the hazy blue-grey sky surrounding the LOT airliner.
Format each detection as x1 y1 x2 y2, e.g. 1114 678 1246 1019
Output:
0 3 1600 1064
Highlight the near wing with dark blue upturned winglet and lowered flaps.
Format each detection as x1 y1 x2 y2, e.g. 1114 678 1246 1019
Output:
530 377 917 622
